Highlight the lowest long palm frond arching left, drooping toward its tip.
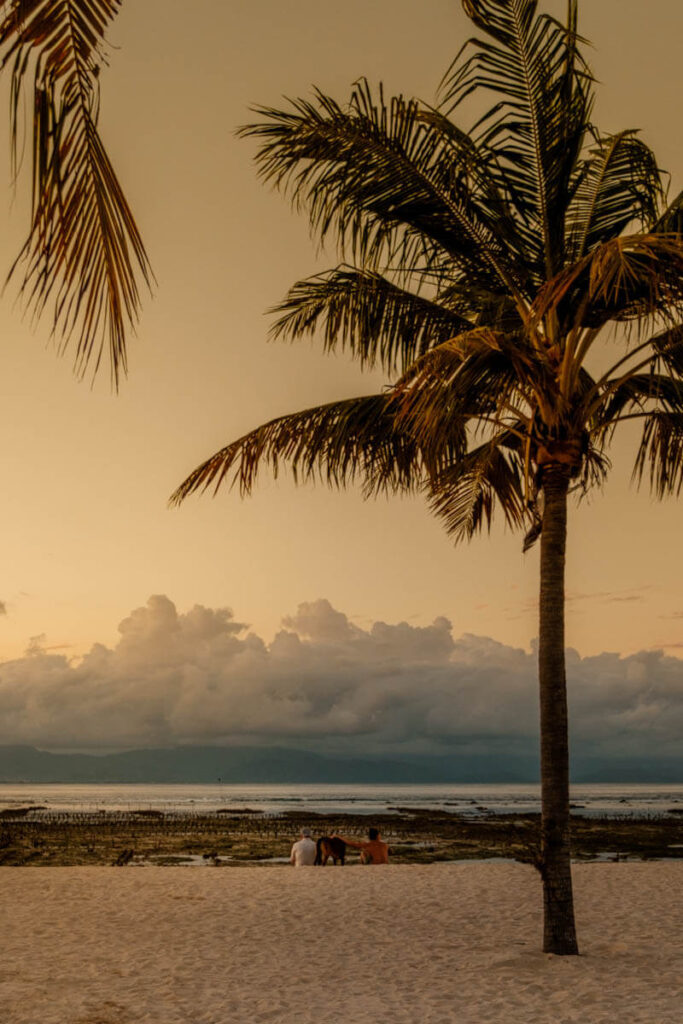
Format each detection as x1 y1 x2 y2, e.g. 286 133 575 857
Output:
170 394 458 505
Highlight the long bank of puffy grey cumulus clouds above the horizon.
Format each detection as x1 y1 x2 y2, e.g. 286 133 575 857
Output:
0 596 683 755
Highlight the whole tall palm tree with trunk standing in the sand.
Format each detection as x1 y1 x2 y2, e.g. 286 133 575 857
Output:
172 0 683 954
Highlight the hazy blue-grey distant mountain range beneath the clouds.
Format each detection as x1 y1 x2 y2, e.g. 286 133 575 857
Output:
0 745 683 784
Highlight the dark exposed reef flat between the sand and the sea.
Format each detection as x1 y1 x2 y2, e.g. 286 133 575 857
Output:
0 807 683 866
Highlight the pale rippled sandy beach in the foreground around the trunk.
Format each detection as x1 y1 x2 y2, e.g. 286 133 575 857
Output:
0 861 683 1024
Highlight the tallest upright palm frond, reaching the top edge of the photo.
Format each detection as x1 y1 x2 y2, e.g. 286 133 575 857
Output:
444 0 592 278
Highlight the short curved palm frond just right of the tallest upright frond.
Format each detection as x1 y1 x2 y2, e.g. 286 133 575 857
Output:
567 131 664 260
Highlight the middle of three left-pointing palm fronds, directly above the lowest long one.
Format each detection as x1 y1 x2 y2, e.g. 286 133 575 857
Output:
272 266 472 375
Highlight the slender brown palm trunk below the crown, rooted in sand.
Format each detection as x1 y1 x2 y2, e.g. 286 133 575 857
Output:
539 464 579 955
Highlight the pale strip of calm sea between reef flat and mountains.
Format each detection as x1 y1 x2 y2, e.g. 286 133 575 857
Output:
0 783 683 816
